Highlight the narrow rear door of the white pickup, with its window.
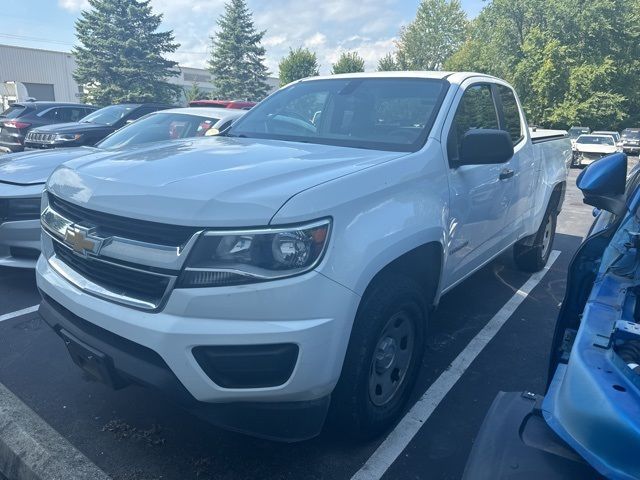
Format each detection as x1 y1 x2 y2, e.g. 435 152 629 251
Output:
493 84 537 242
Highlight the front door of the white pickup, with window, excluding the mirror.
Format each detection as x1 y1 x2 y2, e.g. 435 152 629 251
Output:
442 82 514 285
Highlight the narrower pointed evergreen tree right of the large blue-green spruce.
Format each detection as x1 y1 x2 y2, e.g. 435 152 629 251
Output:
209 0 269 101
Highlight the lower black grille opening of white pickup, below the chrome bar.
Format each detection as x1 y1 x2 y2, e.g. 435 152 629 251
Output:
53 240 171 305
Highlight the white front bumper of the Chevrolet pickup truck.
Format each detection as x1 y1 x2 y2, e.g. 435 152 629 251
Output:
36 256 359 438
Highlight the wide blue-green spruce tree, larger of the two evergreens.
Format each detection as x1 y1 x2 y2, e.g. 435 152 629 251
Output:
73 0 180 105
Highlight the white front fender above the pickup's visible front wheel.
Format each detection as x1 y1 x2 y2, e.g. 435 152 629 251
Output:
271 142 449 295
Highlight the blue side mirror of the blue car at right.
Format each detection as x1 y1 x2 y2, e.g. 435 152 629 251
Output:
576 153 627 216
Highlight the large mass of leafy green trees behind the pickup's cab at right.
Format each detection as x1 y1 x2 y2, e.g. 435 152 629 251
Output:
445 0 640 129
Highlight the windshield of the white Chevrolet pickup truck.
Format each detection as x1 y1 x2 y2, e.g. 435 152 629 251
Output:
227 78 448 151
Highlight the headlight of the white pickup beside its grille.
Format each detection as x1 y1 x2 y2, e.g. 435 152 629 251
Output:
178 219 331 288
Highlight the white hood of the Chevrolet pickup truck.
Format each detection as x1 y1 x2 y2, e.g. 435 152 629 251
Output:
47 137 406 227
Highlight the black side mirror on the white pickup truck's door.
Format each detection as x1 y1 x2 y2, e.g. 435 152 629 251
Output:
458 129 513 165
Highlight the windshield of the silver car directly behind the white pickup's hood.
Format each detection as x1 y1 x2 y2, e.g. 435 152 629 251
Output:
96 112 219 148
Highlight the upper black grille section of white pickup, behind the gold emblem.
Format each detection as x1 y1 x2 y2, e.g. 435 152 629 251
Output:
48 193 199 247
